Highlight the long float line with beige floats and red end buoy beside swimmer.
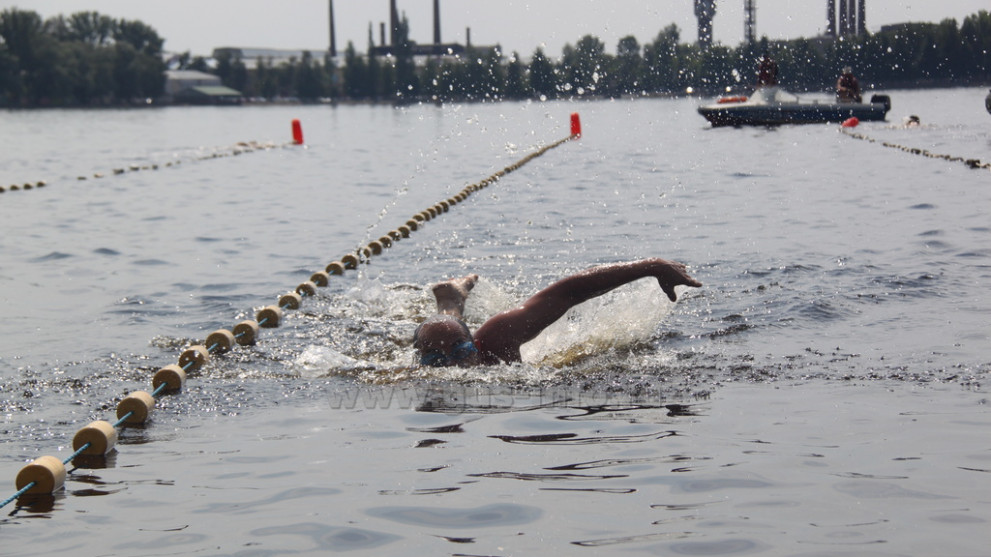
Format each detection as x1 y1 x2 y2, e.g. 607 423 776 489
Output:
0 114 581 514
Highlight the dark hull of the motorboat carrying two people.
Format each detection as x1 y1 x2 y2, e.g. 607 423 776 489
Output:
698 102 888 126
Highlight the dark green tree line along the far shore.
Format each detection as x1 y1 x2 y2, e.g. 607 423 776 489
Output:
0 9 991 106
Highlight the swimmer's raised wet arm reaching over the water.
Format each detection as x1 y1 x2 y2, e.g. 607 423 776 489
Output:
474 258 702 361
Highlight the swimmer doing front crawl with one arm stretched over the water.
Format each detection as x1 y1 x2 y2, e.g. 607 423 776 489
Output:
413 258 702 367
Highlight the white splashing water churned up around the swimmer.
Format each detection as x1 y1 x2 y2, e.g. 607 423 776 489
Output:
292 272 673 383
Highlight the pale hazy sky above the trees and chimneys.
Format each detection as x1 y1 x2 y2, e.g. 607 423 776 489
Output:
9 0 991 57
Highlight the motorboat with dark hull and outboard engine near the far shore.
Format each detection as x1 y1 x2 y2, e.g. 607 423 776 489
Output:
698 86 891 126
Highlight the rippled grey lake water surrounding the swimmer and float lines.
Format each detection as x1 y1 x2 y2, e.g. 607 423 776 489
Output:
0 88 991 556
